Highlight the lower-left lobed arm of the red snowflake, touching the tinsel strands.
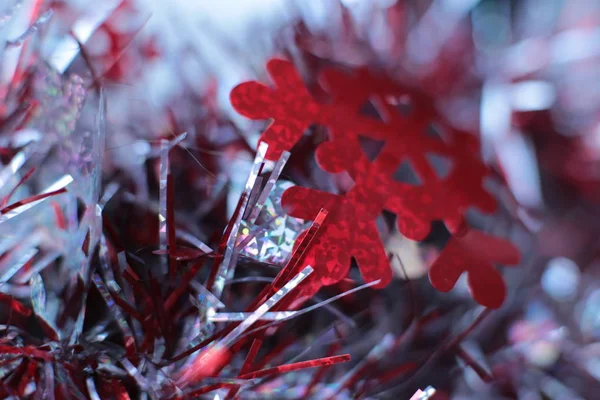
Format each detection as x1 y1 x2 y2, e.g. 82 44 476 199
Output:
281 152 393 287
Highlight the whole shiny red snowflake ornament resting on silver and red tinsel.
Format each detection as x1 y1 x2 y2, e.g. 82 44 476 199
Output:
231 60 519 308
